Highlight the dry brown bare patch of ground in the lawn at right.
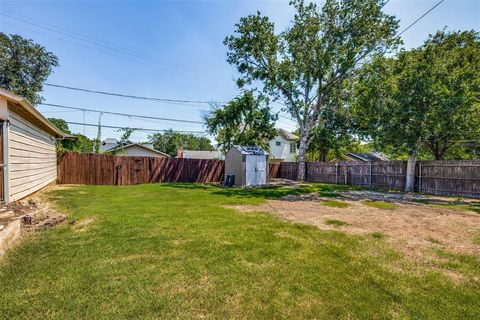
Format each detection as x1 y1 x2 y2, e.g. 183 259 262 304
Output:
230 195 480 260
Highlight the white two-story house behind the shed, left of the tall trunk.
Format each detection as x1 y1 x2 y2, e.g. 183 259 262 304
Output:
268 129 299 162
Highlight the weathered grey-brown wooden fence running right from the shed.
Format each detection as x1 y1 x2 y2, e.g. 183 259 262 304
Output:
278 160 480 198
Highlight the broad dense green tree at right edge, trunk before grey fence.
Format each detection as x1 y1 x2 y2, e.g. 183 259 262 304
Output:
353 31 480 191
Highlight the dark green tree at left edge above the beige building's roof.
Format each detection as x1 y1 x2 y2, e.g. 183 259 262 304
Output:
0 32 58 105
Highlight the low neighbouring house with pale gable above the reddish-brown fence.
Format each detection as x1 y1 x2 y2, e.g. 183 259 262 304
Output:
100 138 170 158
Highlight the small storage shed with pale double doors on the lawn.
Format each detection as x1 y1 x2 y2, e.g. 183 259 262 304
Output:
225 146 268 187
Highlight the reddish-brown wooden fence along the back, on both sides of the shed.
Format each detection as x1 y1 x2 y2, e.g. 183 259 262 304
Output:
57 152 280 185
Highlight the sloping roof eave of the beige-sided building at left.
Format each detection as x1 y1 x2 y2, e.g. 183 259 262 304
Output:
0 88 66 138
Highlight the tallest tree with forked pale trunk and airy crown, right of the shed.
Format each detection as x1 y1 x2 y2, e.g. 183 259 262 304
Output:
225 0 399 180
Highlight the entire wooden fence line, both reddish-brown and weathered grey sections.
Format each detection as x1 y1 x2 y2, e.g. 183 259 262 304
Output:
58 152 480 198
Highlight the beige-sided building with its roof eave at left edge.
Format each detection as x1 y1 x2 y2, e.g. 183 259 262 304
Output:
0 89 69 203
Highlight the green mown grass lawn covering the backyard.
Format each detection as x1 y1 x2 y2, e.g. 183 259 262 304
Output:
0 184 480 319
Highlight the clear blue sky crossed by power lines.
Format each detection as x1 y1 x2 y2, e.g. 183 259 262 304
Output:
0 0 480 141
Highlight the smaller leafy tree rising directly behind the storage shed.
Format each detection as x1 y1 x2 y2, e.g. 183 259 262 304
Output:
205 91 277 152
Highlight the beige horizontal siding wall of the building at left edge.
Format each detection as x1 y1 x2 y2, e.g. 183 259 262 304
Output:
8 112 57 201
